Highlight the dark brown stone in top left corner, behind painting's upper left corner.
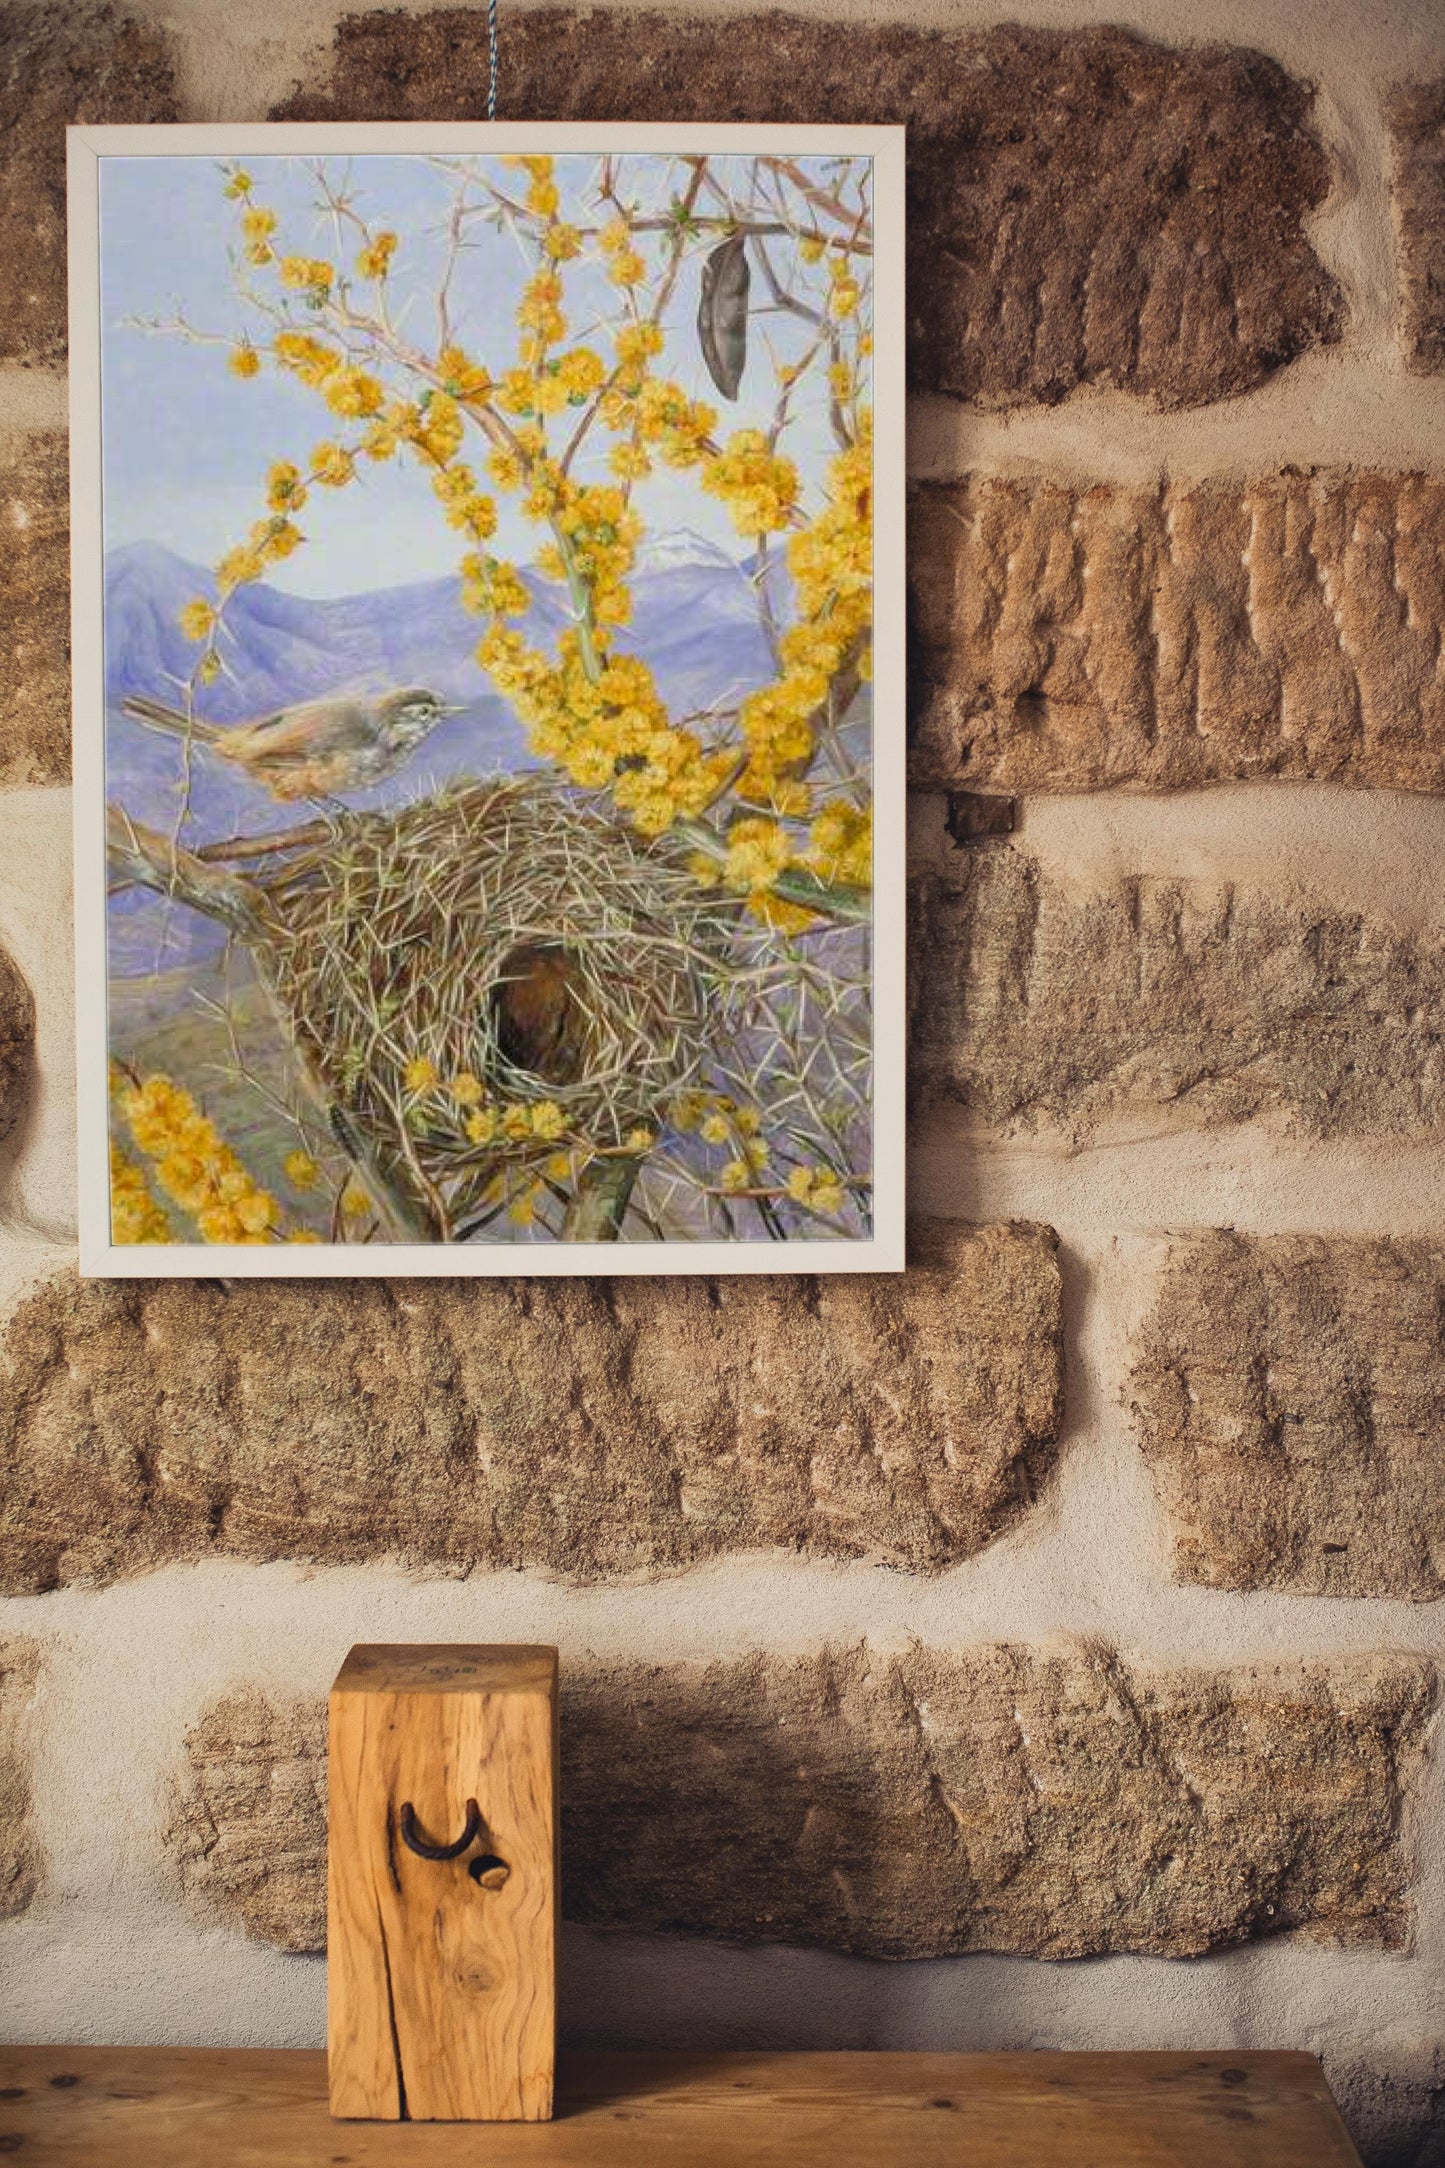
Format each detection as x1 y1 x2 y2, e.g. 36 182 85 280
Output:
0 0 178 362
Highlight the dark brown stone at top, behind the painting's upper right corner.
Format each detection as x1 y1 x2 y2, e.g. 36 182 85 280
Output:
275 9 1343 408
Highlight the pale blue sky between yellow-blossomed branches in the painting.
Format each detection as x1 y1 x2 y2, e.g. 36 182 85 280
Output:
100 154 870 596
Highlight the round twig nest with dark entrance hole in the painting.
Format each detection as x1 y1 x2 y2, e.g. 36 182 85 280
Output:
244 776 750 1231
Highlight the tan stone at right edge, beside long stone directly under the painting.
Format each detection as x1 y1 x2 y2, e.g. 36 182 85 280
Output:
1133 1231 1445 1598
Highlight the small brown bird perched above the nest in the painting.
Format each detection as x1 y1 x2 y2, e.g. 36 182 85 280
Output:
121 685 457 800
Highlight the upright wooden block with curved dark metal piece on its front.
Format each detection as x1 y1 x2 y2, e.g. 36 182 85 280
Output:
327 1643 557 2122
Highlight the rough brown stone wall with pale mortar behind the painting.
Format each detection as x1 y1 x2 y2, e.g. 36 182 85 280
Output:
0 0 1445 2168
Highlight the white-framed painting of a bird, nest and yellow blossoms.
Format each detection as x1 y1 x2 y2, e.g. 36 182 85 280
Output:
71 126 903 1275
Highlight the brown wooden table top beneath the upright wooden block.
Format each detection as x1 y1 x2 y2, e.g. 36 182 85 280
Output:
0 2047 1358 2168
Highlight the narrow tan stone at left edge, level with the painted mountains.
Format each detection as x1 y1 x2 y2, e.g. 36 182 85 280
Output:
0 431 69 787
